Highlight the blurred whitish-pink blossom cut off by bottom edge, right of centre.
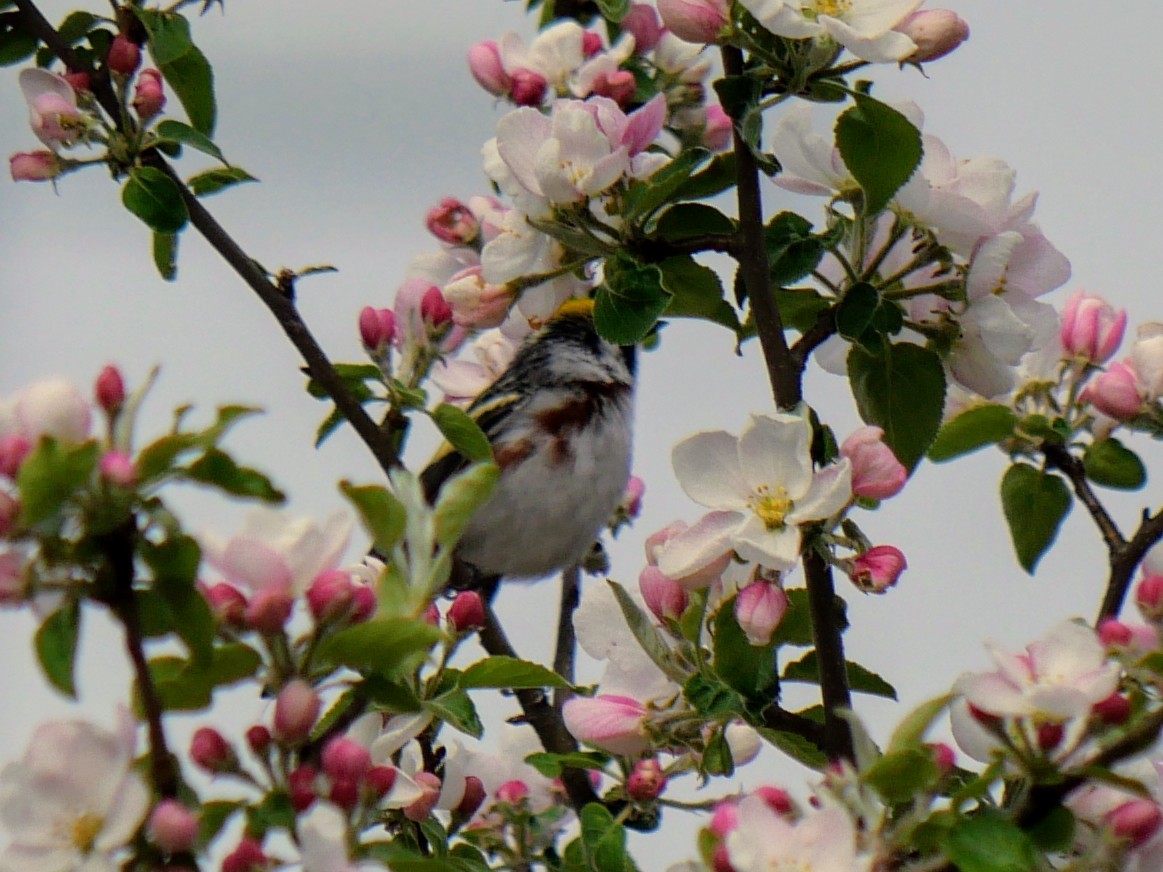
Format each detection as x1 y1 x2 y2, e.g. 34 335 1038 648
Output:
727 796 875 872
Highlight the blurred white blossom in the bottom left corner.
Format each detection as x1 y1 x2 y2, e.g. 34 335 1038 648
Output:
0 715 150 872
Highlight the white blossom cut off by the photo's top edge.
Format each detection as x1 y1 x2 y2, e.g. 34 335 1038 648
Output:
740 0 921 63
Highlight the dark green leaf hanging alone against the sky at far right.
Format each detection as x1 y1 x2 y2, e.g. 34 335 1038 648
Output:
1001 463 1071 574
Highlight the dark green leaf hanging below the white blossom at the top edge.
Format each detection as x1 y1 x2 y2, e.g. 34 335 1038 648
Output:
836 93 922 217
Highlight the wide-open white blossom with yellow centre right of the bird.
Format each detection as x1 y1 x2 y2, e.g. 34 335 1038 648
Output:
658 414 852 578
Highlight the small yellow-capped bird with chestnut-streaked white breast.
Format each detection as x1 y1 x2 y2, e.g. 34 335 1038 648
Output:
420 300 635 593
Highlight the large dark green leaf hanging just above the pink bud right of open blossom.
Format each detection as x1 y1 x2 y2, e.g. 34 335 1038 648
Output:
848 342 946 470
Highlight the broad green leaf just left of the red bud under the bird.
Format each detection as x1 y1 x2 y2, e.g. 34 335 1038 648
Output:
319 617 441 680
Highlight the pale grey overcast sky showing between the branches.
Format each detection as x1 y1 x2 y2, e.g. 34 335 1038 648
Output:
0 0 1163 867
